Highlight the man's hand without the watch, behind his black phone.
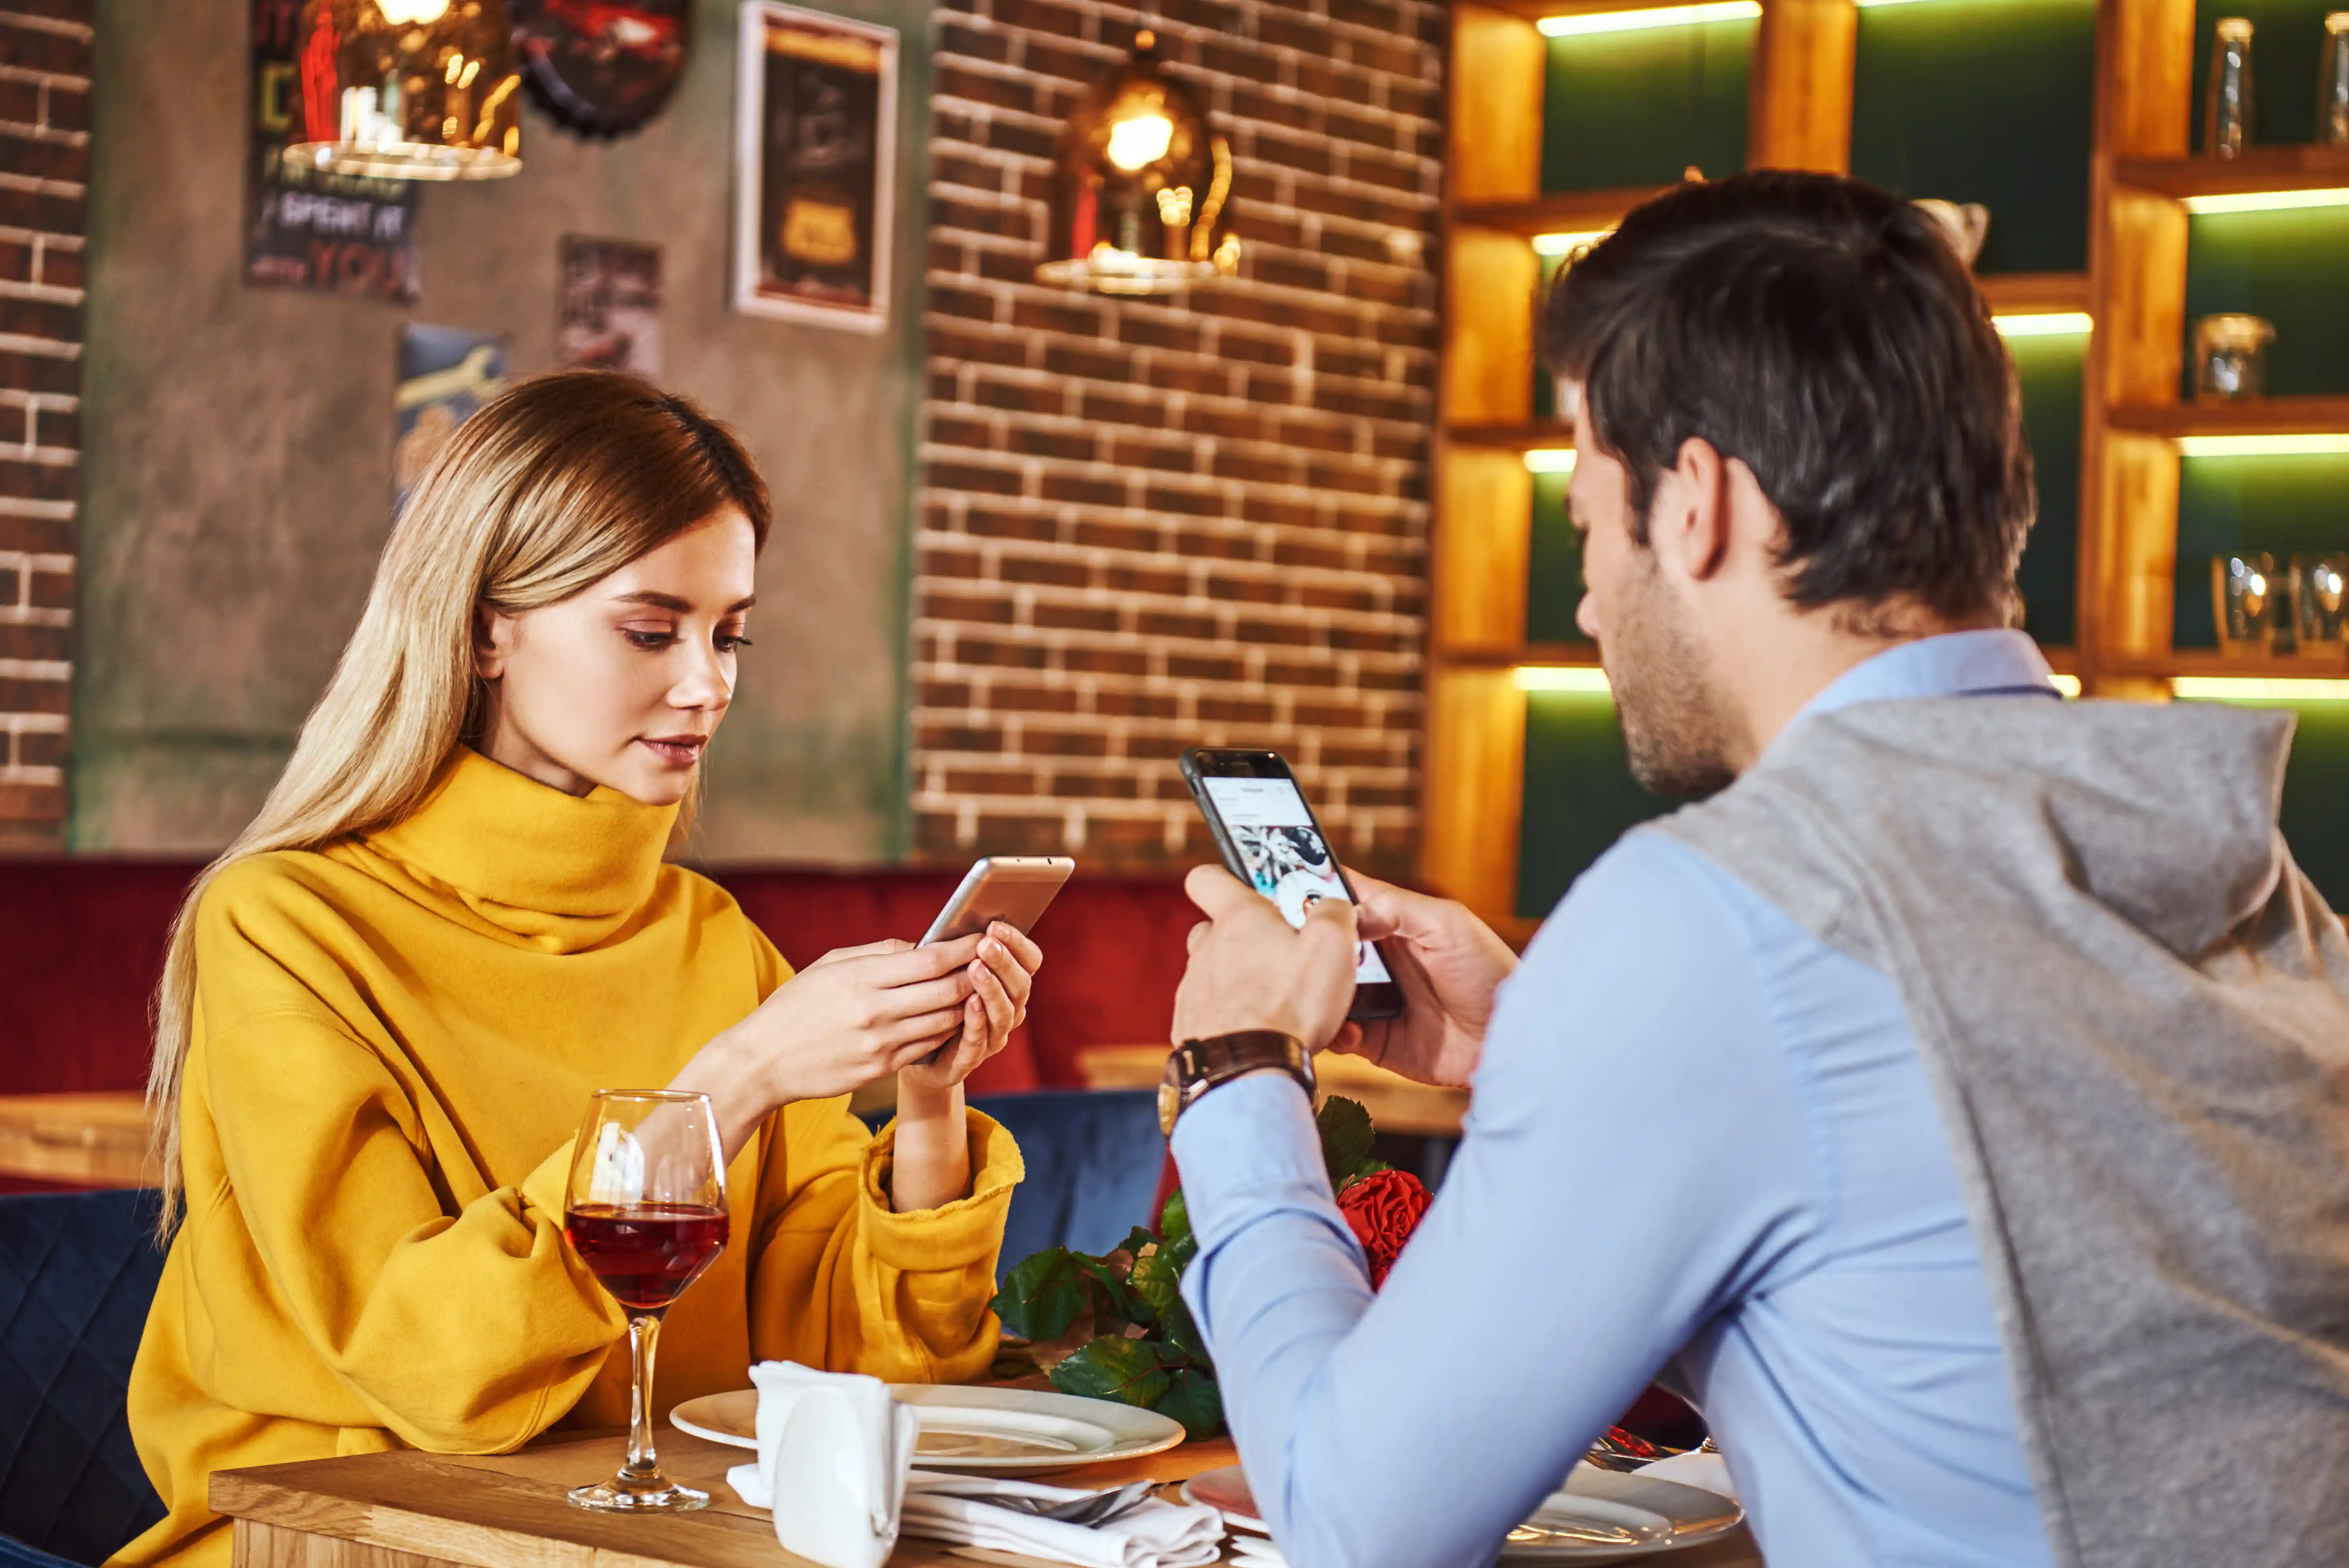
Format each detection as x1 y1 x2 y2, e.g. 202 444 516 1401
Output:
1329 872 1518 1088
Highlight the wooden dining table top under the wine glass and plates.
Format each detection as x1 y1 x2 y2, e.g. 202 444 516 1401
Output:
211 1429 1762 1568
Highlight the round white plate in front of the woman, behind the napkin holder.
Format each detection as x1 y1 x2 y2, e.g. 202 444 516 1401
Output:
669 1382 1184 1476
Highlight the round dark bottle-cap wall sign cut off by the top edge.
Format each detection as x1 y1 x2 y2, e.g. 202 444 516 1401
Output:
507 0 693 136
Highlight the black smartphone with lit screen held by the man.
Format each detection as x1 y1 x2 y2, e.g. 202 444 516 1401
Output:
1182 745 1402 1018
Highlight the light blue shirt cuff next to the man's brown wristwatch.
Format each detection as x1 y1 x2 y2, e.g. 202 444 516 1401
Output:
1172 1072 1337 1248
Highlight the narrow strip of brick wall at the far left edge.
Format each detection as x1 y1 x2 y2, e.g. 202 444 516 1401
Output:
0 0 94 849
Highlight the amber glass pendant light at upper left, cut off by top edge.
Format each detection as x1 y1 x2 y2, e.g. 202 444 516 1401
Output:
284 0 521 179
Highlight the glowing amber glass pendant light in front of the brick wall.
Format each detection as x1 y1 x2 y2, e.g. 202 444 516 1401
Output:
1036 31 1240 294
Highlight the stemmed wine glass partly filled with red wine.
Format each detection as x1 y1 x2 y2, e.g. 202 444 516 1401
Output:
564 1088 728 1514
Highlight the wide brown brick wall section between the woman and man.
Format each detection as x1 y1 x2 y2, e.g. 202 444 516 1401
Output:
914 0 1444 870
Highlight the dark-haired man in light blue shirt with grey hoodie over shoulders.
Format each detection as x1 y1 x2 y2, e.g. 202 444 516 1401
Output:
1170 174 2349 1568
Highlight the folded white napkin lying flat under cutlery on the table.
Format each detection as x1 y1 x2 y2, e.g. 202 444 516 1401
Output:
902 1472 1224 1568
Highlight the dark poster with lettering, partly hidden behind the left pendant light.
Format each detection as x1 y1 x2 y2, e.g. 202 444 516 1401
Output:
244 0 418 301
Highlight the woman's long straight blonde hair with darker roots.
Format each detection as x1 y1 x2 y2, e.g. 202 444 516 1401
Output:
148 371 771 1234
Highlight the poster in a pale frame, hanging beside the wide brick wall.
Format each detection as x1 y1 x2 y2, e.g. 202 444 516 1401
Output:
733 0 897 331
